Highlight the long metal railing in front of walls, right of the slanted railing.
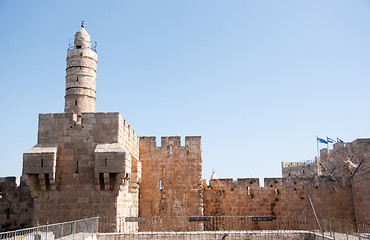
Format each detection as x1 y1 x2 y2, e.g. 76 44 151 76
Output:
99 216 370 239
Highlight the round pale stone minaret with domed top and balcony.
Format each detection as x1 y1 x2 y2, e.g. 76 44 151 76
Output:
64 25 98 116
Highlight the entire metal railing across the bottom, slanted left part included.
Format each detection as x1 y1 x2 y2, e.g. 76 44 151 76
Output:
0 216 370 240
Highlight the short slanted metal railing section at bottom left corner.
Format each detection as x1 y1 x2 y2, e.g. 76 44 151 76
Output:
0 218 99 240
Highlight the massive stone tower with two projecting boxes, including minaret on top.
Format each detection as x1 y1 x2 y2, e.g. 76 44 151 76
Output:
22 27 141 225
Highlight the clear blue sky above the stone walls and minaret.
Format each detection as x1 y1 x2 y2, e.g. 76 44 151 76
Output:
0 0 370 183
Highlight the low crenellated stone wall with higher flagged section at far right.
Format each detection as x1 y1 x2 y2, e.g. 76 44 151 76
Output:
203 139 370 222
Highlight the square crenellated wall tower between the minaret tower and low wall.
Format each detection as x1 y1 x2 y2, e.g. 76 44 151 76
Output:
139 136 203 217
